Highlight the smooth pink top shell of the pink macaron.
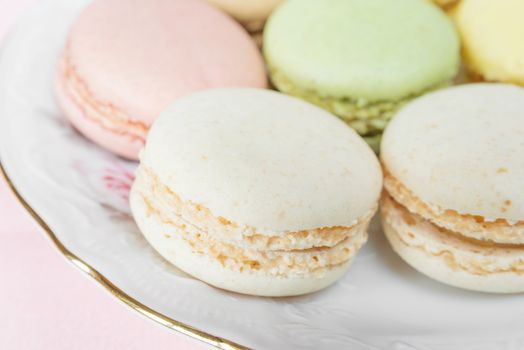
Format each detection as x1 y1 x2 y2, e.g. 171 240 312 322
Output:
66 0 266 123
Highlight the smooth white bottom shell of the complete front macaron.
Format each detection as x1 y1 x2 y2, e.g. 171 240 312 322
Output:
130 187 354 297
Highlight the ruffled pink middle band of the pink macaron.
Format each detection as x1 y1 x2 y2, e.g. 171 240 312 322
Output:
59 48 149 142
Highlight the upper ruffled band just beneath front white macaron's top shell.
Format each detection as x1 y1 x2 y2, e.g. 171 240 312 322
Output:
135 164 376 250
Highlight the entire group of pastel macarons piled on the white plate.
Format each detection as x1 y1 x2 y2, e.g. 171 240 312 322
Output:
55 0 524 296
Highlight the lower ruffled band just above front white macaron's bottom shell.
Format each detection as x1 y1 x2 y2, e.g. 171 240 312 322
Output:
133 165 368 276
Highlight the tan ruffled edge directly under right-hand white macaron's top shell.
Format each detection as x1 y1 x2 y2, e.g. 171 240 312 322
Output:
384 167 524 244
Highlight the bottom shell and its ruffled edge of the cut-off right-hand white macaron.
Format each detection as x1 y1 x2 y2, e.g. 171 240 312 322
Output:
381 193 524 293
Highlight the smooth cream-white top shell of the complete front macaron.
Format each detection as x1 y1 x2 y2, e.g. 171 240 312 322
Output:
140 88 382 233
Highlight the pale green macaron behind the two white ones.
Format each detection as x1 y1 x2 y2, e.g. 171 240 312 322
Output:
264 0 460 149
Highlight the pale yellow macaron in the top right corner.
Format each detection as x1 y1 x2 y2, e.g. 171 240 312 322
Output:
452 0 524 86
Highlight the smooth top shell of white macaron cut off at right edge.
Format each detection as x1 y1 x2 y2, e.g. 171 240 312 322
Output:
381 84 524 222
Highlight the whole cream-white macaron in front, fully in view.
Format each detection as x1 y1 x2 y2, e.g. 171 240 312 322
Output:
130 88 382 296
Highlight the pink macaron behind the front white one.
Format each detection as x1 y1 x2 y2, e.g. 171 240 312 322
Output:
55 0 267 159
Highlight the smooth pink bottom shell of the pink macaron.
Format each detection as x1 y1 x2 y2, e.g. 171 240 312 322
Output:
55 77 144 160
